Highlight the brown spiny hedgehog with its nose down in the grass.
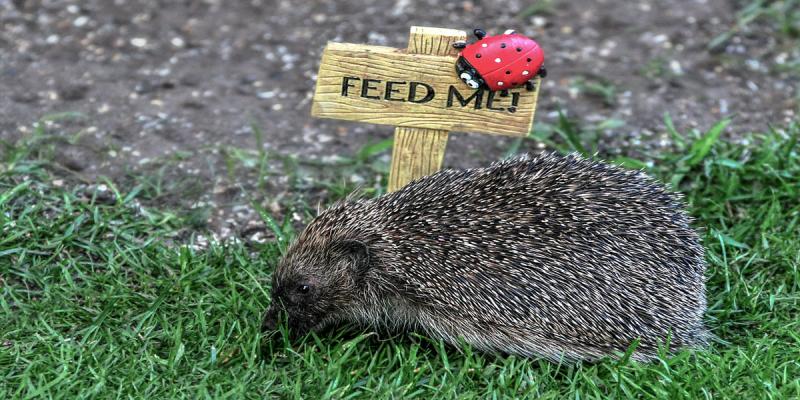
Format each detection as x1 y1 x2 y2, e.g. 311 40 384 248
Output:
262 153 710 361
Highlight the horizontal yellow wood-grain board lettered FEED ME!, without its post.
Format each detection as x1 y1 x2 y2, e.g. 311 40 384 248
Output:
311 42 539 136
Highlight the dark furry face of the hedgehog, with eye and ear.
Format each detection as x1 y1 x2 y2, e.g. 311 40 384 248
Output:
262 241 368 336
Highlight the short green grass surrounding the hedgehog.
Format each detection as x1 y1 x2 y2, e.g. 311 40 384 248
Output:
0 118 800 399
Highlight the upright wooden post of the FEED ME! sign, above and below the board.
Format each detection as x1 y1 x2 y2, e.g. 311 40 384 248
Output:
387 26 467 192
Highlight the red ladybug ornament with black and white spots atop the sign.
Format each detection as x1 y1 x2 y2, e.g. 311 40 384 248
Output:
453 29 547 91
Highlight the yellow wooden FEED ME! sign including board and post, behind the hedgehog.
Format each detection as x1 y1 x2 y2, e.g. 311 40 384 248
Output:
311 26 540 191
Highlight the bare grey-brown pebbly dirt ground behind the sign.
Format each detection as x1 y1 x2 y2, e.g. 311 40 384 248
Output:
0 0 800 240
